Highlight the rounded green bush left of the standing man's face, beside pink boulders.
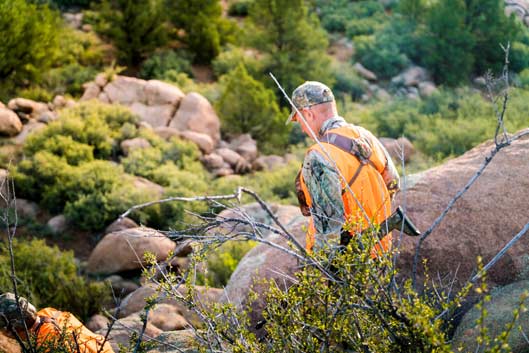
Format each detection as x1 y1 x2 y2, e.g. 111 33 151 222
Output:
217 64 288 151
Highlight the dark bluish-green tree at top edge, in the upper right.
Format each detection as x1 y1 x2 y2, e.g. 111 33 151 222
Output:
423 0 475 85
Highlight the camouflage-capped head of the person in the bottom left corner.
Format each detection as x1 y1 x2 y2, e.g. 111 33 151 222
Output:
0 293 37 332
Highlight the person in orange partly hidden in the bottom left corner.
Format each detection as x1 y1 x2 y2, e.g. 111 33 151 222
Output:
0 293 114 353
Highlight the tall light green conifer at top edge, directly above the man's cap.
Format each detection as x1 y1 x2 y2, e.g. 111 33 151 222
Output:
250 0 333 96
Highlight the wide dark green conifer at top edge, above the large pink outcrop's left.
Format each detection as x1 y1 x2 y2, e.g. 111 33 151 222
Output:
96 0 167 66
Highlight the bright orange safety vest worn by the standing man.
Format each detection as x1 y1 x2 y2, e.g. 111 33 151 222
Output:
300 125 391 257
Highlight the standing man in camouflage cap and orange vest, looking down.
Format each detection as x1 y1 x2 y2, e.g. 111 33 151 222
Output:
286 81 399 256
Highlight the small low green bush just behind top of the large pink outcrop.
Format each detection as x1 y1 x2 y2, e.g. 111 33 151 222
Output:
140 50 192 80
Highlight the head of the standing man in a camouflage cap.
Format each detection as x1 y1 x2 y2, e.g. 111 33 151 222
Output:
286 81 338 136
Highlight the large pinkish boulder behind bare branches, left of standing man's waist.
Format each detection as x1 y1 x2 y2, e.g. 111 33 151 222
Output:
221 213 308 337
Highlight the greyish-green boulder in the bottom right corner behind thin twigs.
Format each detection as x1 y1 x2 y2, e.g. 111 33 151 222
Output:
452 280 529 353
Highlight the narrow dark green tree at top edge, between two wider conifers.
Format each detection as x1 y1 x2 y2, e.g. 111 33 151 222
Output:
167 0 223 63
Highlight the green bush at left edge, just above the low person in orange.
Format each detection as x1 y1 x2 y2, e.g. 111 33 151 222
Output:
0 240 110 320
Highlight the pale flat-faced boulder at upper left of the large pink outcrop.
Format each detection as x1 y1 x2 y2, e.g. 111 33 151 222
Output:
103 76 147 105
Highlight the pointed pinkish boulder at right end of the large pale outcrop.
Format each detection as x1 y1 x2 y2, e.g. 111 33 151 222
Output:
169 92 220 142
